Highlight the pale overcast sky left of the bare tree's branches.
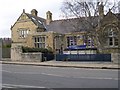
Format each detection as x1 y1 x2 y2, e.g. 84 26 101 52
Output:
0 0 62 38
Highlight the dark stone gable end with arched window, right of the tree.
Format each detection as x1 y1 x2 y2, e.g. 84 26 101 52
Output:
98 10 120 53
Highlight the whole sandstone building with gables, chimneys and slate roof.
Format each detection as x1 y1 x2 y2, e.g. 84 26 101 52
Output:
11 5 120 62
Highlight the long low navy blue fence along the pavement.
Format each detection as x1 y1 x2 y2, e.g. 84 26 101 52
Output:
56 54 111 62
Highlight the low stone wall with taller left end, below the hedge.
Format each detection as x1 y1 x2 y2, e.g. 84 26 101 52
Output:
11 44 42 62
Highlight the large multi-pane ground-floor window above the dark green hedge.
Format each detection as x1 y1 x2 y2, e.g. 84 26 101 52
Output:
34 36 45 48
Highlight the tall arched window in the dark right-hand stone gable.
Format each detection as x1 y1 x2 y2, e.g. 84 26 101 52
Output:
106 26 118 47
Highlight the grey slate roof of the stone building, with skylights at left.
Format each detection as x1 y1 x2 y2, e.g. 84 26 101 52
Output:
26 13 120 34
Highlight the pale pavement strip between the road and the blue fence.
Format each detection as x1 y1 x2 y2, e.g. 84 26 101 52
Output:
0 60 120 69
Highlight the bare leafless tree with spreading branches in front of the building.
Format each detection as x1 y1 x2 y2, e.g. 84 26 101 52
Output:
61 0 117 51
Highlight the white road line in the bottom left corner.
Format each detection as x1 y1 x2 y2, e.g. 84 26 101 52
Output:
2 84 46 88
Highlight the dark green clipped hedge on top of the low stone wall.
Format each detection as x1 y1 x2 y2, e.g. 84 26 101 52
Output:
22 47 52 53
